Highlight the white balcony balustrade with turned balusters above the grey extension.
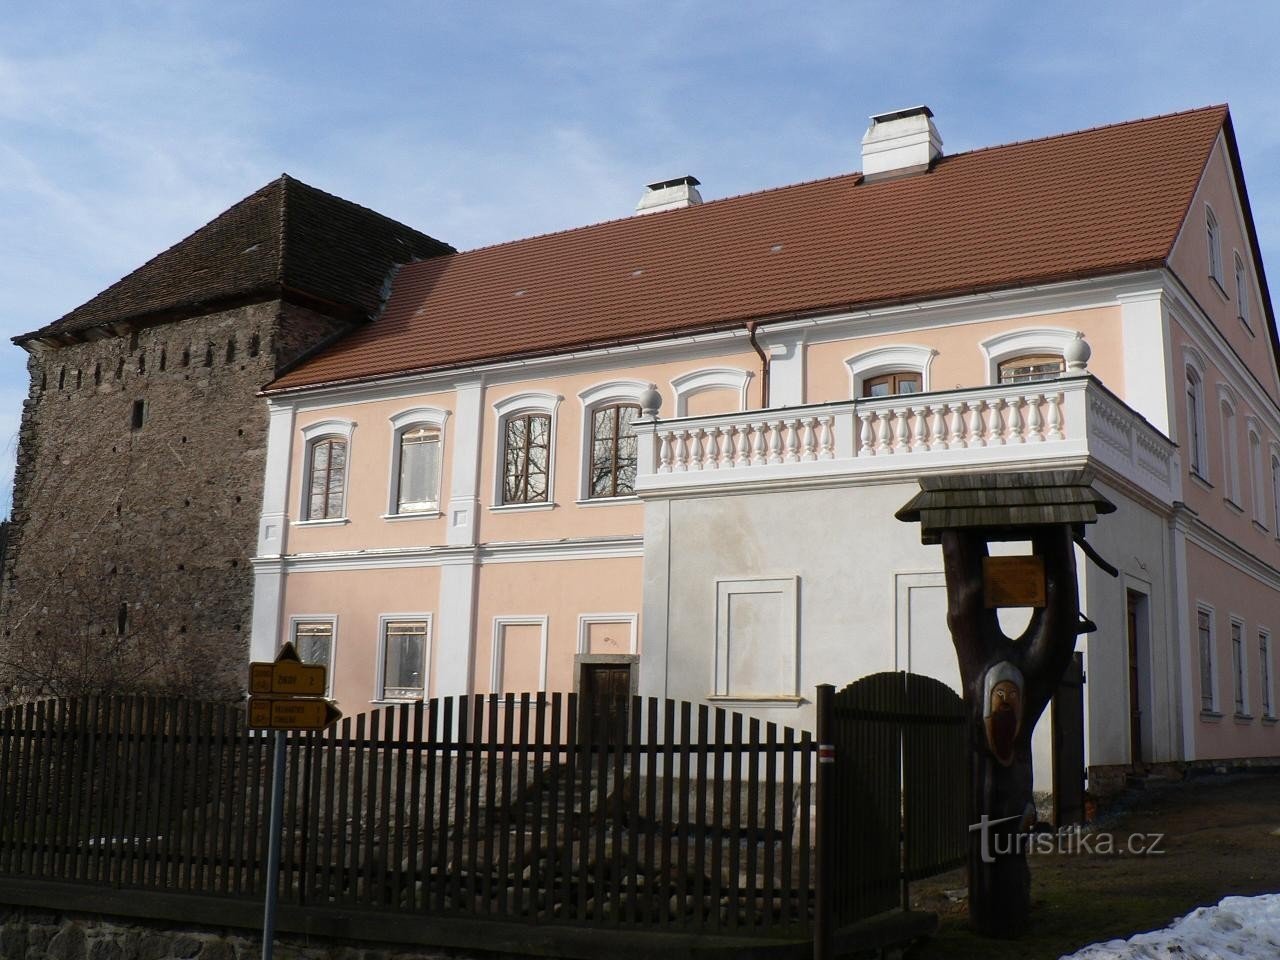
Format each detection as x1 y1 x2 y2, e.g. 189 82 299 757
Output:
635 375 1180 503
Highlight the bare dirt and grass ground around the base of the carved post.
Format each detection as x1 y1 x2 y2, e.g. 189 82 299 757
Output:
906 774 1280 960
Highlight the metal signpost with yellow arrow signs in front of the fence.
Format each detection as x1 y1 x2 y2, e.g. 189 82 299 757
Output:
248 643 342 960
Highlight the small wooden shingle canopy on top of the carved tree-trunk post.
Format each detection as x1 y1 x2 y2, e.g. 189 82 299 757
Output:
895 470 1116 544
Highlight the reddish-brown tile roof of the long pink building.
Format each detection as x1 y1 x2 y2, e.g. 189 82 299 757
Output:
268 106 1228 390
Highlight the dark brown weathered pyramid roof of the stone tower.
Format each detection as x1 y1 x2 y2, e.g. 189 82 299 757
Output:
14 174 453 343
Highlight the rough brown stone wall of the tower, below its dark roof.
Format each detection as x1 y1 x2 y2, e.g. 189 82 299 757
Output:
0 301 345 700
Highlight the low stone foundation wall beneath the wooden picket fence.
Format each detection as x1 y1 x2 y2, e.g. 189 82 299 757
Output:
0 906 486 960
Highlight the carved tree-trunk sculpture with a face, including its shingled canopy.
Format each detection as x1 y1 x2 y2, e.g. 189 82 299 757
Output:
897 472 1115 937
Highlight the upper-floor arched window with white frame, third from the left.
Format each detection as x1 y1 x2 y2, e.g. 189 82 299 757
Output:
494 393 561 506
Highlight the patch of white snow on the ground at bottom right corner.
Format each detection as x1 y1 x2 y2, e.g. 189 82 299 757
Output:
1061 893 1280 960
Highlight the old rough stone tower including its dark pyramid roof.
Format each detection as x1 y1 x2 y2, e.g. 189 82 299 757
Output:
0 175 452 703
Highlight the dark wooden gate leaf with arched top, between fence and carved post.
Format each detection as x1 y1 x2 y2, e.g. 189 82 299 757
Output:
828 672 969 927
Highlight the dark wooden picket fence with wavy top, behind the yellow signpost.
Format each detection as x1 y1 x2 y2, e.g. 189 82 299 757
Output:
0 694 814 938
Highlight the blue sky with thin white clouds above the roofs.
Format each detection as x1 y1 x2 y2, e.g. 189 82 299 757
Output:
0 0 1280 515
